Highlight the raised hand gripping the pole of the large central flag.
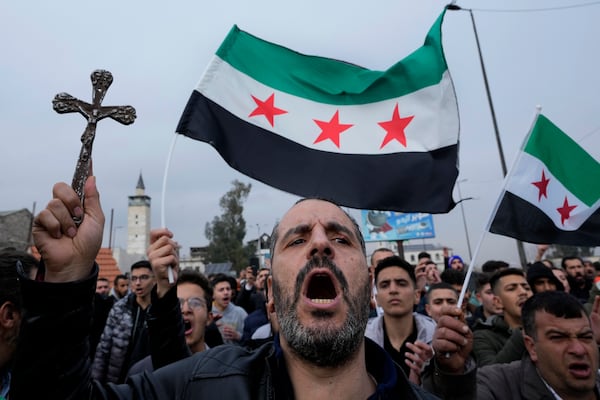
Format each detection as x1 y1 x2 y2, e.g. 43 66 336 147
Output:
146 228 179 298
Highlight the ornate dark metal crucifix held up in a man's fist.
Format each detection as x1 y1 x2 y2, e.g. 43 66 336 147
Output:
52 69 135 224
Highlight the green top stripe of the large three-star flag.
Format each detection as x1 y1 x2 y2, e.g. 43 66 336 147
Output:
217 10 447 105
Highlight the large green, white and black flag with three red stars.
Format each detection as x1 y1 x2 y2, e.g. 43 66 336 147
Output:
177 8 459 213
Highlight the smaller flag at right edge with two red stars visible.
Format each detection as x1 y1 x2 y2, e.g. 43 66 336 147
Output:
490 115 600 246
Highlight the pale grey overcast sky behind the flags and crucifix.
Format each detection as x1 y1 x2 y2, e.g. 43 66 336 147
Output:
0 0 600 265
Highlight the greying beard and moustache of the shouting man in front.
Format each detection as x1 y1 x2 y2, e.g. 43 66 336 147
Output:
273 257 371 367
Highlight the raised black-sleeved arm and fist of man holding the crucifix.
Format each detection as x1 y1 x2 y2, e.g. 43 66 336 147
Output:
10 176 104 400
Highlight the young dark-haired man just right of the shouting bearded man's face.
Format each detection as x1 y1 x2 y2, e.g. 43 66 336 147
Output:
365 256 435 384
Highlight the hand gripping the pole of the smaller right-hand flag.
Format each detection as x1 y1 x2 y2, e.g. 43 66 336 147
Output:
432 306 473 374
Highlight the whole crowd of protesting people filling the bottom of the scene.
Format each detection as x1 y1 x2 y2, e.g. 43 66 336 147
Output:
0 177 600 400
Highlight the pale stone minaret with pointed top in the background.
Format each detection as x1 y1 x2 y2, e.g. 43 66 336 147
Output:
127 172 151 255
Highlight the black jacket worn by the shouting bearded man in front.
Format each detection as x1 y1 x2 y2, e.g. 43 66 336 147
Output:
11 266 436 400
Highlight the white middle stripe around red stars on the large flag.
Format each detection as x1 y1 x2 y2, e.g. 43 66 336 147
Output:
196 56 459 154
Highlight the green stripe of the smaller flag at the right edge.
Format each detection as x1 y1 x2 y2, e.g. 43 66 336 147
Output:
523 115 600 207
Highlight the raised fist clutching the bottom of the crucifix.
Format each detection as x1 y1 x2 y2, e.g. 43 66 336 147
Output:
32 176 104 282
